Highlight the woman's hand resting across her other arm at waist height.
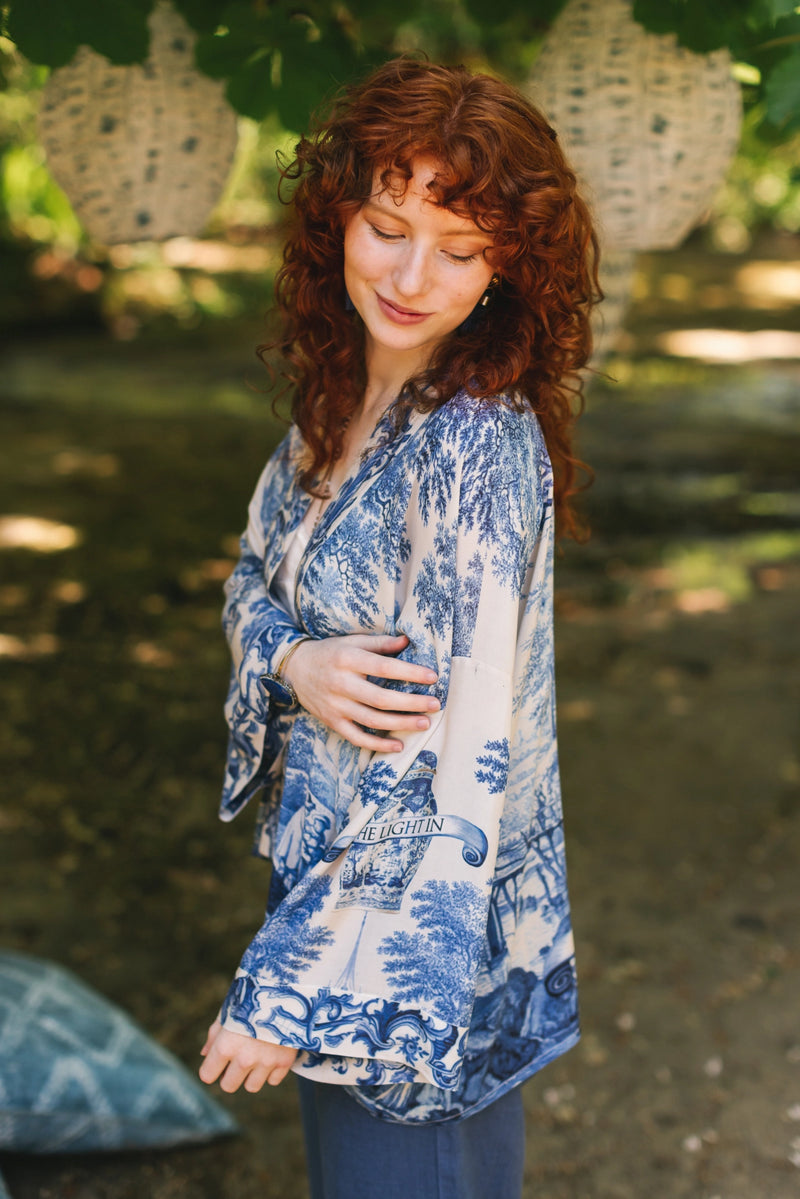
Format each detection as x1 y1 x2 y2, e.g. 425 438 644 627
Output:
283 633 440 753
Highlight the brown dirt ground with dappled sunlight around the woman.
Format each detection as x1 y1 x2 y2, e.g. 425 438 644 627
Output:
0 238 800 1199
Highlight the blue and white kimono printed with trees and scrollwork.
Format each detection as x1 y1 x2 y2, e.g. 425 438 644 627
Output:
221 393 578 1123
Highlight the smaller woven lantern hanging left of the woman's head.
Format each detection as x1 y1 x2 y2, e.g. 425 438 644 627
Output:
38 0 236 245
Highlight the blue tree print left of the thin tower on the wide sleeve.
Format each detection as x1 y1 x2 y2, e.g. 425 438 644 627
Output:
241 878 333 986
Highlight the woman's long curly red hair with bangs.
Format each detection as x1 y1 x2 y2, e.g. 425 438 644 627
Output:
258 58 602 536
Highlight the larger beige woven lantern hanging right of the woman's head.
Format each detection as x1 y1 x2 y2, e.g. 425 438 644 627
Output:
529 0 741 249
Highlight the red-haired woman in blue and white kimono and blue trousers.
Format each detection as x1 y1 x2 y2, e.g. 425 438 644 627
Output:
200 59 597 1199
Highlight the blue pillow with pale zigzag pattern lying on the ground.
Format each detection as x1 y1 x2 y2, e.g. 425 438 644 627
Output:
0 952 237 1155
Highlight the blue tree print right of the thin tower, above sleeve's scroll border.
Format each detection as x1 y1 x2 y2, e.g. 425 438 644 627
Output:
378 880 486 1024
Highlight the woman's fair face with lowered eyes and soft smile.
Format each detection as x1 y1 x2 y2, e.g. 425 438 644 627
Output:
344 158 492 373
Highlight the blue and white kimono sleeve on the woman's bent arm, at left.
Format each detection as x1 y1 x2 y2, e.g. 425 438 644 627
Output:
221 450 307 819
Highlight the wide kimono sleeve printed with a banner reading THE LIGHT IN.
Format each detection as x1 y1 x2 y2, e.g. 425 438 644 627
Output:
215 405 543 1089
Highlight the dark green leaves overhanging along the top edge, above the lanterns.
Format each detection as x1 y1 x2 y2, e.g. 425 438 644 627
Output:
5 0 800 134
